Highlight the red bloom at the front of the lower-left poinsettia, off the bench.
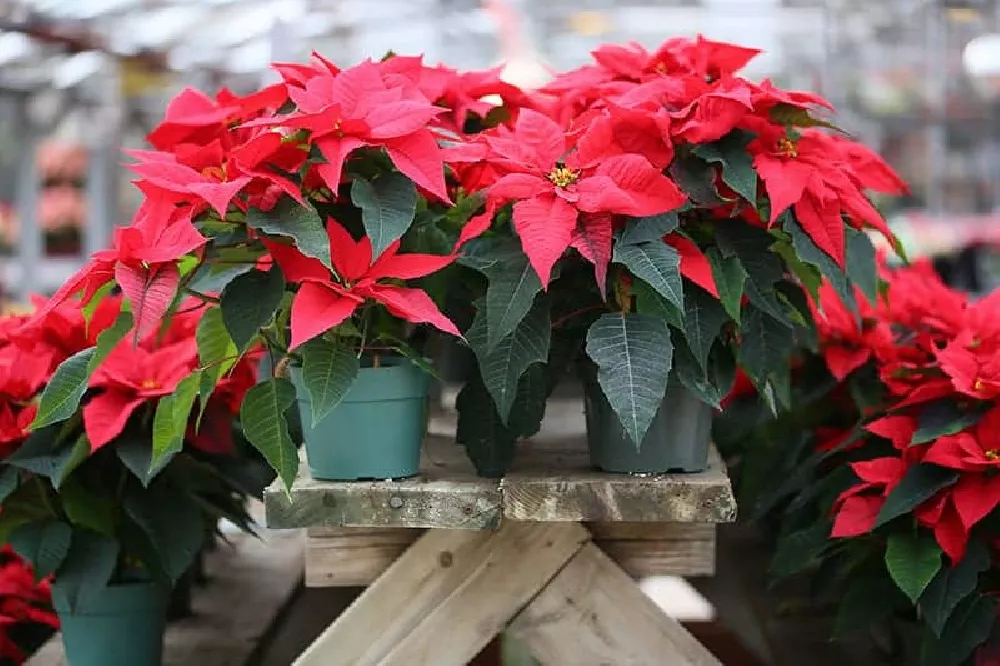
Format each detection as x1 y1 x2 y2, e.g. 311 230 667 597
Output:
83 339 197 451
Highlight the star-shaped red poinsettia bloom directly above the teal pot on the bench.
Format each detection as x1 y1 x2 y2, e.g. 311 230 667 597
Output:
268 219 461 349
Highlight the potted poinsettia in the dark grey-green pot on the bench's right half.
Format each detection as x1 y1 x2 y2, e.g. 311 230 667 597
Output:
446 38 905 473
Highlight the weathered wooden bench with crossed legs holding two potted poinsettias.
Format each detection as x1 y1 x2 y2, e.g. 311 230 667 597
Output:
265 403 736 666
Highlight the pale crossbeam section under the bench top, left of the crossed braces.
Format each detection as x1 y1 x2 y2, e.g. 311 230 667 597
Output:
306 527 424 587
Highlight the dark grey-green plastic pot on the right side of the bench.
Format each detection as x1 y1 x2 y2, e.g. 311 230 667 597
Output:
584 372 712 474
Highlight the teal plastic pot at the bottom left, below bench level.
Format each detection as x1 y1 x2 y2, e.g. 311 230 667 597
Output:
53 583 170 666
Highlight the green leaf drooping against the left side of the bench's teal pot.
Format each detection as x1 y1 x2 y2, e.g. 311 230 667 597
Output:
240 378 299 491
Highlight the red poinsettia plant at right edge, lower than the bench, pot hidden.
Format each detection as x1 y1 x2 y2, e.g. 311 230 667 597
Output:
716 263 1000 666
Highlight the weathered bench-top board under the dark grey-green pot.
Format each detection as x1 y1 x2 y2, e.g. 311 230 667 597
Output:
503 439 736 523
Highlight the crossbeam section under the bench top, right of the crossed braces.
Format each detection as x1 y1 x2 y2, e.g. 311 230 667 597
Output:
592 523 716 578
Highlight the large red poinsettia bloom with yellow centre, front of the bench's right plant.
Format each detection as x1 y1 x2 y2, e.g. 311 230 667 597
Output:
487 109 685 285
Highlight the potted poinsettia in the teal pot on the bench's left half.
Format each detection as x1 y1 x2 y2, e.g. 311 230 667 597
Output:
25 56 478 485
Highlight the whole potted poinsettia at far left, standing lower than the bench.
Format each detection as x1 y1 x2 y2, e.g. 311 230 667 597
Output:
0 295 269 666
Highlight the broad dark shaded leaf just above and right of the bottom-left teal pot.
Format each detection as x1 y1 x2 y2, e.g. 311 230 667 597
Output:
125 490 207 583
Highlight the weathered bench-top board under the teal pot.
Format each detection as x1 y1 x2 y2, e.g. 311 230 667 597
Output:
264 437 500 530
